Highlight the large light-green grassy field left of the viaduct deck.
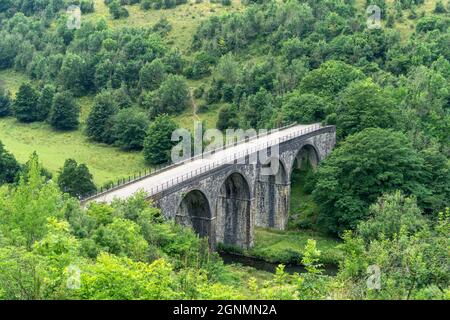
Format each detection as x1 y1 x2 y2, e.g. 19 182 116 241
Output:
0 118 145 185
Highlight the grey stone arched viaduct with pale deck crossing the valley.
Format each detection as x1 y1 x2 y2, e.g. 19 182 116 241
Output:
84 124 336 248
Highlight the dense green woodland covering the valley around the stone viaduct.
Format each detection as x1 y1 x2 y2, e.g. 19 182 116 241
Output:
0 0 450 299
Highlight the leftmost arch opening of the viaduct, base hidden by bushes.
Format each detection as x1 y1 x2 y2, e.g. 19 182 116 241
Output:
176 190 215 246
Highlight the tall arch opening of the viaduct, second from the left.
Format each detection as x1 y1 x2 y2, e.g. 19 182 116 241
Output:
217 173 252 248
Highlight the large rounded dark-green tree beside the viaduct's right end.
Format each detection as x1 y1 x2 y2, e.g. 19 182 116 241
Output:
313 128 428 233
